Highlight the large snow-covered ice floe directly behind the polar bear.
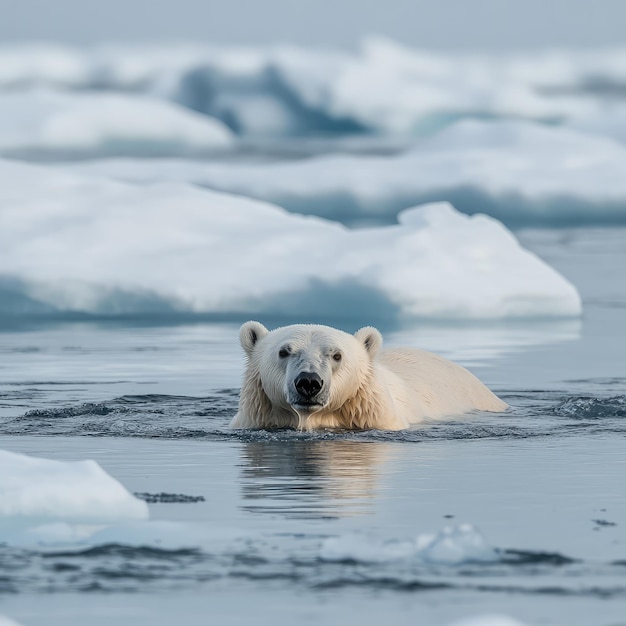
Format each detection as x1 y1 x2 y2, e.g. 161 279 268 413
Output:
0 161 581 319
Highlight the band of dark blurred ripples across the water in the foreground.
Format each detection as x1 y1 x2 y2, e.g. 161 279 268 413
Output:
0 534 626 598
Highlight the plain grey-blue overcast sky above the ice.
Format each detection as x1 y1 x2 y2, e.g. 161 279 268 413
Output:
0 0 626 50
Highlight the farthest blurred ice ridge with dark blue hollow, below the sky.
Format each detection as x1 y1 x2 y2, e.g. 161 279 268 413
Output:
0 38 626 138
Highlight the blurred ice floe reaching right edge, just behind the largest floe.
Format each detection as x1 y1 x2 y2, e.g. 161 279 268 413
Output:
69 118 626 227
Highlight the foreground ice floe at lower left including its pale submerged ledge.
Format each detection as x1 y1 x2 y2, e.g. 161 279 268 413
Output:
0 450 234 548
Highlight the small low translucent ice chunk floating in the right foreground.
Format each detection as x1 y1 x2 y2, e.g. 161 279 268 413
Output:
320 524 499 565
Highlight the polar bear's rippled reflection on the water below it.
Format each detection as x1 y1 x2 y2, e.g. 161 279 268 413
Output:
236 439 402 518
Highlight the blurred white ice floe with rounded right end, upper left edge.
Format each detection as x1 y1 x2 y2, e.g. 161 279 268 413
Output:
0 90 232 156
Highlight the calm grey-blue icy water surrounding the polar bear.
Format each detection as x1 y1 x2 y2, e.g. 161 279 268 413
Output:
0 229 626 626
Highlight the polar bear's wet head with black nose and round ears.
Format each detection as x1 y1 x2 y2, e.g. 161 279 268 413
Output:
239 322 382 427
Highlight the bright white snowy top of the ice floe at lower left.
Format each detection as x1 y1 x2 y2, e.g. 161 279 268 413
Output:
0 450 148 532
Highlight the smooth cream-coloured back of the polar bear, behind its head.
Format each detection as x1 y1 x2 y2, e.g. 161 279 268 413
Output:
376 348 507 424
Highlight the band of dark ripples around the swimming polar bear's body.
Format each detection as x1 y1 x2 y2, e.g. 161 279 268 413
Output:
0 389 626 443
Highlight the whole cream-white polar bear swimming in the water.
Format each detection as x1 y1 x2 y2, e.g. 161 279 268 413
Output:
230 321 507 430
